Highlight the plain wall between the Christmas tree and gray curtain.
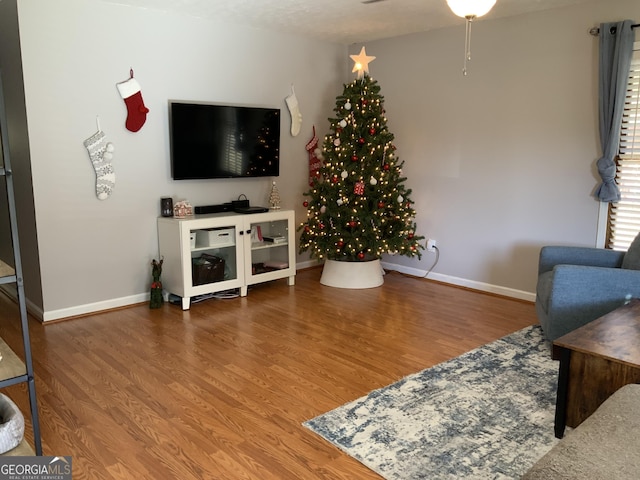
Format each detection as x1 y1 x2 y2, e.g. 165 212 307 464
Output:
370 0 640 299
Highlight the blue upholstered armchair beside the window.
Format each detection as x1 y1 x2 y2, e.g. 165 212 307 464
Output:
536 235 640 341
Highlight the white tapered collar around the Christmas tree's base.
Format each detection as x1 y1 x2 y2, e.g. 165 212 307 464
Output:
320 260 384 288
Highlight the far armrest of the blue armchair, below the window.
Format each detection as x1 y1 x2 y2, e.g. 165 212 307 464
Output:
538 246 625 275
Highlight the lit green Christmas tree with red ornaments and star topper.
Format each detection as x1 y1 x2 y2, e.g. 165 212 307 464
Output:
299 48 424 261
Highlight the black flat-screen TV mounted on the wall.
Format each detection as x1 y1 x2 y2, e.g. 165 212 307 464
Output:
169 101 280 180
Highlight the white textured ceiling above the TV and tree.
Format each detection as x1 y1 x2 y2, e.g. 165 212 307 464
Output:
103 0 606 45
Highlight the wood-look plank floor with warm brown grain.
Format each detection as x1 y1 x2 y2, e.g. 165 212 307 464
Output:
0 269 536 480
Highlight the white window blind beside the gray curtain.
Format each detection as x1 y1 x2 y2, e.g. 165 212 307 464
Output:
607 42 640 250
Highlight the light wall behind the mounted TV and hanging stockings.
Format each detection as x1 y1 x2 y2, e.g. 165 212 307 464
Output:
18 0 347 320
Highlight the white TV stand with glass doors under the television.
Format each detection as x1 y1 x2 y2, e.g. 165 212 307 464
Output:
158 210 296 310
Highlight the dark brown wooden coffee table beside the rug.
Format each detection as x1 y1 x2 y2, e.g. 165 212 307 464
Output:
553 299 640 438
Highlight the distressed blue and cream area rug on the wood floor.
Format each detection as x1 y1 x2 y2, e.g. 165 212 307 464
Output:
304 326 558 480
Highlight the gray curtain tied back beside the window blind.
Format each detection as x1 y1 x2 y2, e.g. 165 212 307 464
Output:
595 20 634 202
